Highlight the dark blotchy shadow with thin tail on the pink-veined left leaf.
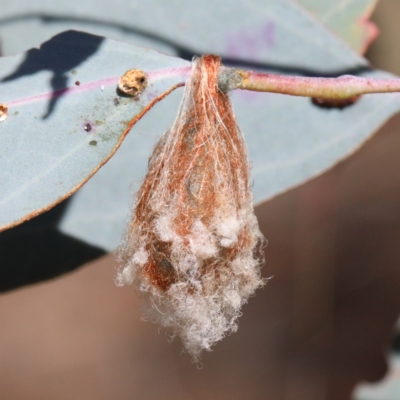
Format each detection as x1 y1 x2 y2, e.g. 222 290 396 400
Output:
2 31 104 119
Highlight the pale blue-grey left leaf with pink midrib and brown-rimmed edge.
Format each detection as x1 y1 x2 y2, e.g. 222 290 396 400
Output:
0 31 189 229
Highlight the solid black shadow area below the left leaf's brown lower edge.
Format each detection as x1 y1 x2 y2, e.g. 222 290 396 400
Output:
0 200 105 292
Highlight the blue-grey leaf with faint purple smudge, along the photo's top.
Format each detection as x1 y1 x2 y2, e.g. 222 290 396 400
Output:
0 0 366 71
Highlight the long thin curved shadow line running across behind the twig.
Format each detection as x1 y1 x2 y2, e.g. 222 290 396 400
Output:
0 13 372 77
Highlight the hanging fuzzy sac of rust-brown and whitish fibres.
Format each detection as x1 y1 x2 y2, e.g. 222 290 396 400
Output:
117 55 265 360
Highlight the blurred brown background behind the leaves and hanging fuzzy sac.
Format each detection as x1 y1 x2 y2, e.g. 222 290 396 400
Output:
0 0 400 400
